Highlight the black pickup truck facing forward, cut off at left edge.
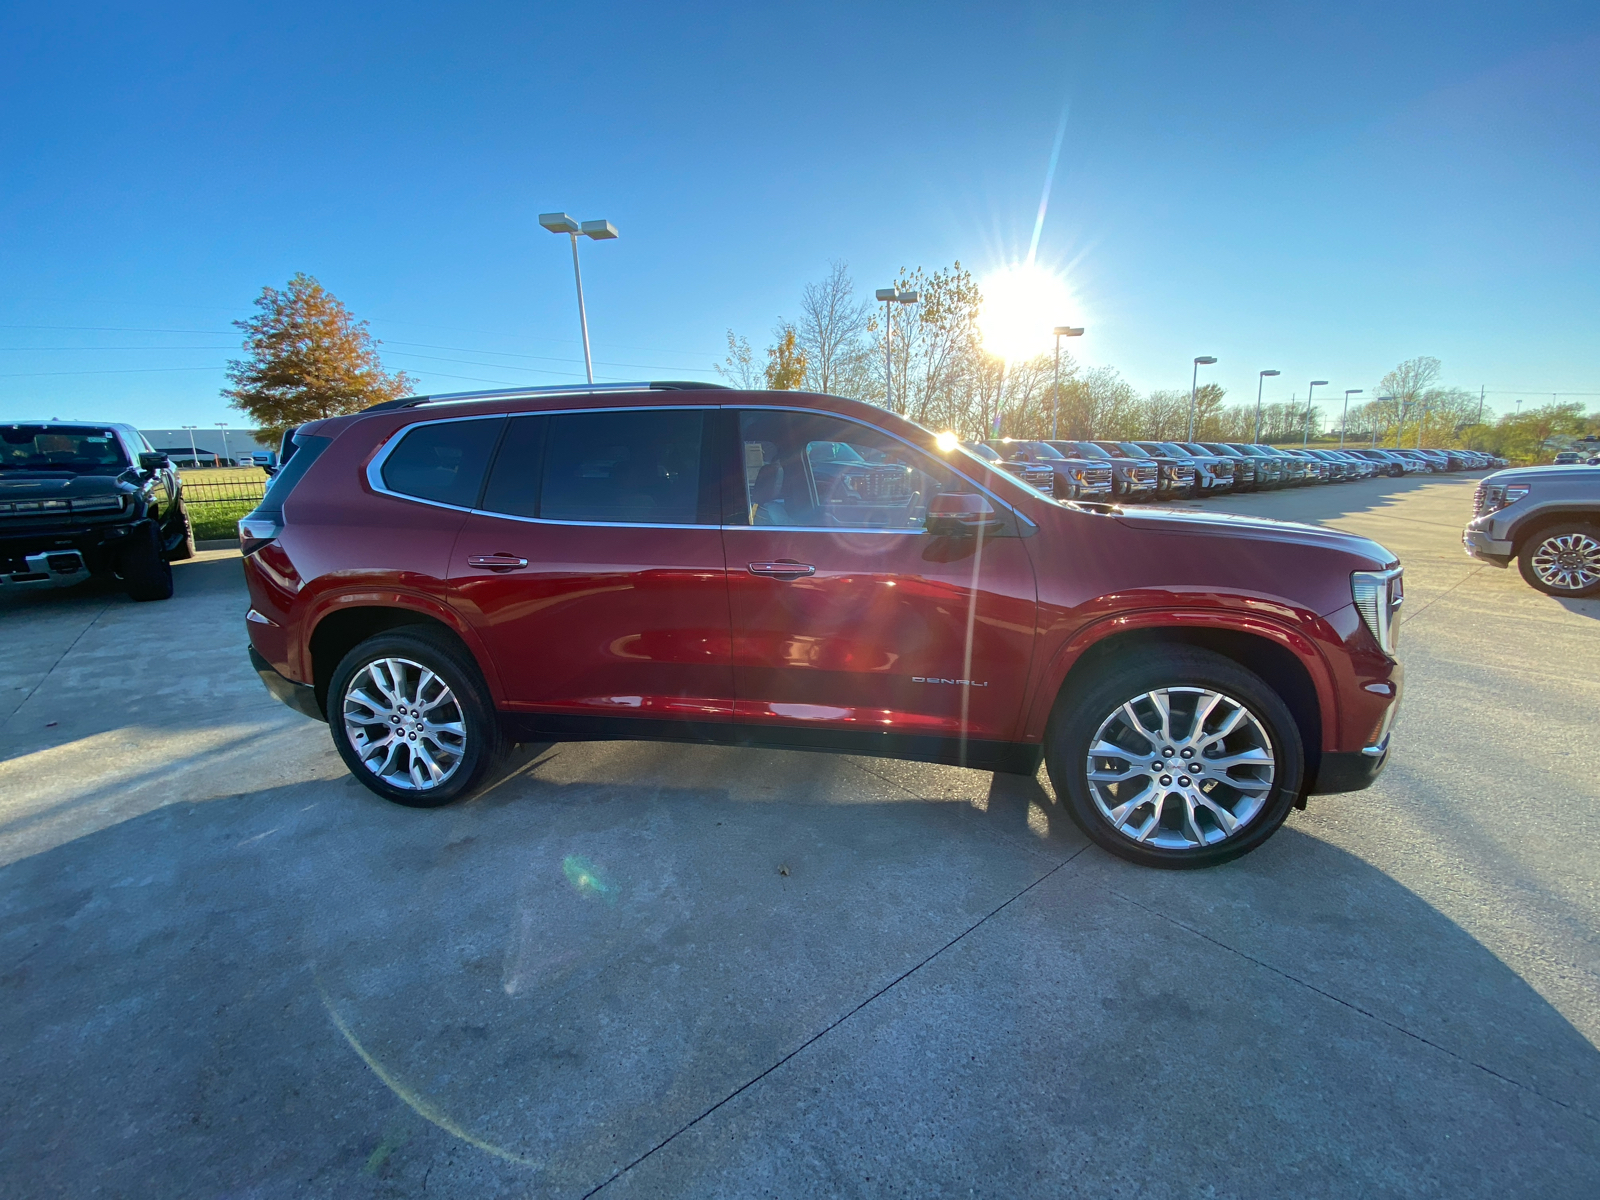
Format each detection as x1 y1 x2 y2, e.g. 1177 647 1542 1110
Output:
0 421 194 600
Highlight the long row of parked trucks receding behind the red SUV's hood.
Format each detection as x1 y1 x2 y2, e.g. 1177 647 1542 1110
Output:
968 437 1506 502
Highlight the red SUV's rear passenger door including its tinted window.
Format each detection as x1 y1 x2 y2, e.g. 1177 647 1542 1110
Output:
450 408 733 722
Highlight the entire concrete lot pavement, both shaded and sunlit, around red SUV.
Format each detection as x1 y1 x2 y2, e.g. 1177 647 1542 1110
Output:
0 477 1600 1197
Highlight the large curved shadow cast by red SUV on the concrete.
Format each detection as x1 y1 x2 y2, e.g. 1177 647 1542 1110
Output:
0 744 1600 1197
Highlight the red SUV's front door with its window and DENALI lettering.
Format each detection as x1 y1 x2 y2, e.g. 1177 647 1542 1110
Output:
723 408 1037 752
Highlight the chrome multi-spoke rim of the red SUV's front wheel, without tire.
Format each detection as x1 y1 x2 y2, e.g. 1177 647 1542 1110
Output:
1086 688 1275 850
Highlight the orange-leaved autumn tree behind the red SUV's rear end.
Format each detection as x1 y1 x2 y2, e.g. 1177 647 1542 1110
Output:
222 274 416 442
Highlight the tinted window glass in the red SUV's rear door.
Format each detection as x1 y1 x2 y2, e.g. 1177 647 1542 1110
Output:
539 410 706 525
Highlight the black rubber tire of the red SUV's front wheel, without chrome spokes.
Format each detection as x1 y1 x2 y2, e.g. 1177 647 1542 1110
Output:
1045 646 1306 870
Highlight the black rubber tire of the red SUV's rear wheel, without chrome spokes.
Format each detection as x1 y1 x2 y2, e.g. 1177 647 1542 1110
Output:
326 627 509 808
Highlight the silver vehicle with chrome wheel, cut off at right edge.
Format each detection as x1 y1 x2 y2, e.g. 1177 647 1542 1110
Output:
1461 466 1600 597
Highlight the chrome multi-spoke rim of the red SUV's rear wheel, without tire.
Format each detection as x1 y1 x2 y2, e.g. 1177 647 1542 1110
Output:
342 658 467 792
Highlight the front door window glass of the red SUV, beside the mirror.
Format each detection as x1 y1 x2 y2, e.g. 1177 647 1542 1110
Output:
739 410 971 530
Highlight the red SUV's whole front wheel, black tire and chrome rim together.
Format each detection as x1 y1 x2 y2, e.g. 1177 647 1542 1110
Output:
1045 646 1306 869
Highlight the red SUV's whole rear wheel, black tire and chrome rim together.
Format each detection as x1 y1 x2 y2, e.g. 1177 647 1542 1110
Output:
326 629 506 808
